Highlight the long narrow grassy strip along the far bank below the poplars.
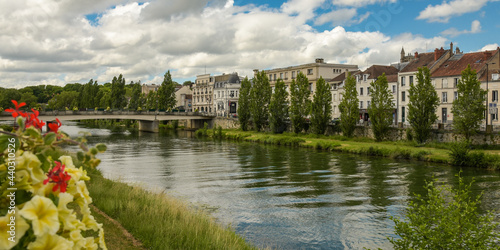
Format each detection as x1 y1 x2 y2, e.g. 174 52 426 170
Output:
201 129 500 169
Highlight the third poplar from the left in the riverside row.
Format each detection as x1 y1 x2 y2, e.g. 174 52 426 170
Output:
269 79 288 134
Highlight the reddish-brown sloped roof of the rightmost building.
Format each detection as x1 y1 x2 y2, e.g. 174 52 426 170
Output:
432 50 496 77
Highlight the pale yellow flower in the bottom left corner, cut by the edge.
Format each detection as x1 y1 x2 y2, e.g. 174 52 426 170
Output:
0 209 30 249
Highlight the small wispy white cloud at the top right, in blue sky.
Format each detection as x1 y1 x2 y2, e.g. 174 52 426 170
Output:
417 0 488 23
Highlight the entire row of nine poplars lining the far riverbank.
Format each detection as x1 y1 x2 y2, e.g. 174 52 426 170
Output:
238 65 486 143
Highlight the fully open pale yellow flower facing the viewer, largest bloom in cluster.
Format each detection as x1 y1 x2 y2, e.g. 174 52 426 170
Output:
20 195 59 236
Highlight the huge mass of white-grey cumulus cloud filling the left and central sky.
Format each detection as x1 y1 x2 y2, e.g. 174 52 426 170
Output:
0 0 446 87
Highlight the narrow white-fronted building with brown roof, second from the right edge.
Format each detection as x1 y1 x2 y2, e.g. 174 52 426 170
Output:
398 43 454 123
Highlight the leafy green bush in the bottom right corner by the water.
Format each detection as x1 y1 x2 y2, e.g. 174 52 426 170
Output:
389 175 500 249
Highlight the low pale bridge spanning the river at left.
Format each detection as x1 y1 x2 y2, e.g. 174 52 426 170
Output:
0 111 215 133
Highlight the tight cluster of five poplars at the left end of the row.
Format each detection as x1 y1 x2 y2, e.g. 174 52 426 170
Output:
238 71 332 134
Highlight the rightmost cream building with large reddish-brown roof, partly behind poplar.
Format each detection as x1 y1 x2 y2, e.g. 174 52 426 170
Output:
431 46 500 125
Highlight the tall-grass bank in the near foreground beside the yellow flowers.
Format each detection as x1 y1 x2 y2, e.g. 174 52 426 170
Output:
88 168 255 249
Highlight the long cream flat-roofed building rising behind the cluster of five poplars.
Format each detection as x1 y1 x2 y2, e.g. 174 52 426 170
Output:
254 58 358 96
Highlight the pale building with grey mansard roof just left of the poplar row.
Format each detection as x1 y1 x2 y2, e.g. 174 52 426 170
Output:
212 73 242 116
